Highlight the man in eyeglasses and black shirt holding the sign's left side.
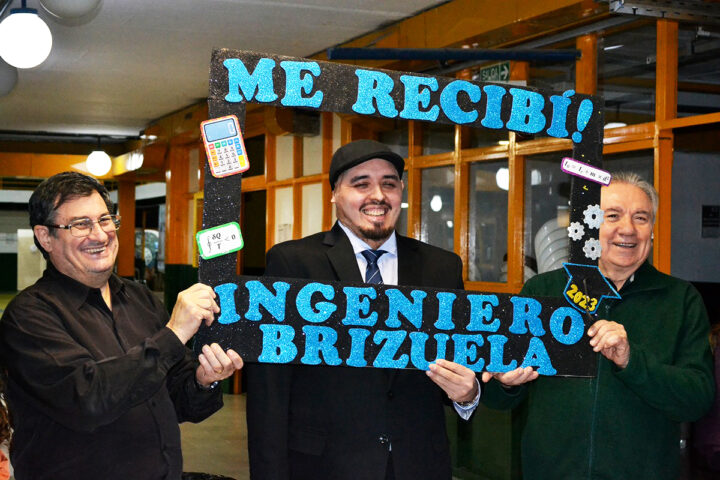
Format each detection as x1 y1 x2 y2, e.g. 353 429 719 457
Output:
0 172 243 480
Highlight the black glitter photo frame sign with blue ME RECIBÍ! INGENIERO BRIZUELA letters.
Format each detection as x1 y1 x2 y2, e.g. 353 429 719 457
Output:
196 49 615 376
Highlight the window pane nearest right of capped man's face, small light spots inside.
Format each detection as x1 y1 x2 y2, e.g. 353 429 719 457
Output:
420 165 455 250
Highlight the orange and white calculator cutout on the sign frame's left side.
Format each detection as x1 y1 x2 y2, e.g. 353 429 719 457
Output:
200 115 250 178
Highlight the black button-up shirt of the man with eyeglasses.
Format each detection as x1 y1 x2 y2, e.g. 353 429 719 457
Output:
0 263 222 480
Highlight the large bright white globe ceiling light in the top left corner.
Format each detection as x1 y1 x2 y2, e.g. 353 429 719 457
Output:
0 0 52 68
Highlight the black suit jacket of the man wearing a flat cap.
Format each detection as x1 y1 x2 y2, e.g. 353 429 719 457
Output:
246 224 463 480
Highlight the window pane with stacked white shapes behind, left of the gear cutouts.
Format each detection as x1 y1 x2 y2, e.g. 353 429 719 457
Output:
524 152 572 280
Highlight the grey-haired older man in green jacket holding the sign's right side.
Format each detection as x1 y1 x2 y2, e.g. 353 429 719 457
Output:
482 174 715 480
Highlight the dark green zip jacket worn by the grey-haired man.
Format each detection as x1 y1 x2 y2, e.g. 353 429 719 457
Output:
482 263 715 480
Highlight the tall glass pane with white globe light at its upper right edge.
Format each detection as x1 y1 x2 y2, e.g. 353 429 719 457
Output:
468 160 508 282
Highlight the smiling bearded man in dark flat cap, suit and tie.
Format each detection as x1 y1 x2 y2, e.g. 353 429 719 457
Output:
246 140 480 480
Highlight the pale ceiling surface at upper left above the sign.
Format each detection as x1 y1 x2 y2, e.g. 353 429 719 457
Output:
0 0 445 136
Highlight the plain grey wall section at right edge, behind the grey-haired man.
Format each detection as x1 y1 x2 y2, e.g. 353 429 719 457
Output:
671 151 720 283
